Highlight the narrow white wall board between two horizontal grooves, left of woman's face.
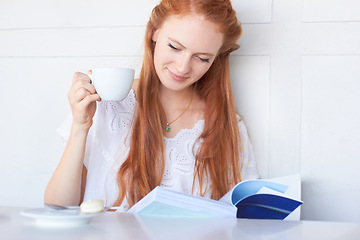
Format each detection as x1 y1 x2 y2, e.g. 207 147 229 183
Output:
0 27 145 57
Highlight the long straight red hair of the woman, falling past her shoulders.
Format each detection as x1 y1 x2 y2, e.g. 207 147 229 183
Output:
115 0 243 206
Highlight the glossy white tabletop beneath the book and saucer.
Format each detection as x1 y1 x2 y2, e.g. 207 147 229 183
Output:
0 207 360 240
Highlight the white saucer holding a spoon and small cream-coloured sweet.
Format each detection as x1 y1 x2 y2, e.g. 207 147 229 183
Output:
20 208 105 226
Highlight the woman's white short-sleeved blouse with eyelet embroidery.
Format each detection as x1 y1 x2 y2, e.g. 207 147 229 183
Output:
58 90 259 211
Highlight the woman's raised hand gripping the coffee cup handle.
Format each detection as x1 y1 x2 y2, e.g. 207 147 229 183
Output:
68 72 101 130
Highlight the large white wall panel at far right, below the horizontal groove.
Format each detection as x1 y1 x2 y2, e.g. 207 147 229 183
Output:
301 56 360 221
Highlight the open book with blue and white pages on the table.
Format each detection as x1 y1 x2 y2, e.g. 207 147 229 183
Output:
128 175 303 219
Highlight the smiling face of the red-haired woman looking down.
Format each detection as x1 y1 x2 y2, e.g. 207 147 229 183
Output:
152 15 223 91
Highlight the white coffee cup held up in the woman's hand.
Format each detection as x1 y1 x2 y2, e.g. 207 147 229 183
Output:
88 68 135 101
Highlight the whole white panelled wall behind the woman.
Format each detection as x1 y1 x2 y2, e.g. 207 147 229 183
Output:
0 0 360 221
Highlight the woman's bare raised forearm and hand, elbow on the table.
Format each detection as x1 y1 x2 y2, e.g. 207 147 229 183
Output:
45 73 100 205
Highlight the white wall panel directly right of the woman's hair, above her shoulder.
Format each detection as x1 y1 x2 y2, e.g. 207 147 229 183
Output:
231 56 270 177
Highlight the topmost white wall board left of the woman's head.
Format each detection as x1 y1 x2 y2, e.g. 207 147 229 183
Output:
0 0 159 29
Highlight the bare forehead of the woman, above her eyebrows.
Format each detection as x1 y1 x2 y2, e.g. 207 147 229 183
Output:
159 14 223 54
